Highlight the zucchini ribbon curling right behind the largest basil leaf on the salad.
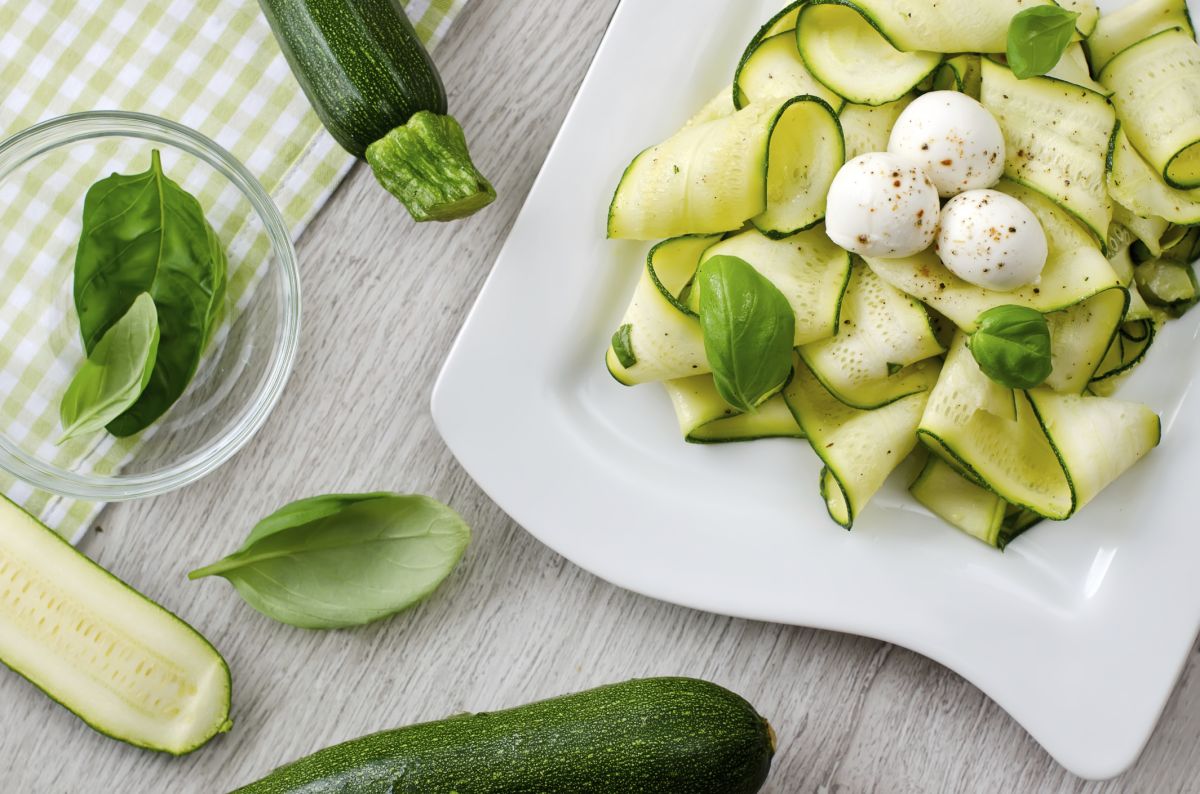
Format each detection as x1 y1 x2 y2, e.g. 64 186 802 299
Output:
694 227 851 345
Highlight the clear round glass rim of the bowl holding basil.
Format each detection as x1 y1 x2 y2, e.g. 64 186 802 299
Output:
0 110 300 501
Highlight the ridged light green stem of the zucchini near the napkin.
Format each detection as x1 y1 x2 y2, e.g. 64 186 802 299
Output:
366 110 496 221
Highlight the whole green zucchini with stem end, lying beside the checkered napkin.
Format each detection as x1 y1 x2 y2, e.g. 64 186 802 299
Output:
259 0 496 221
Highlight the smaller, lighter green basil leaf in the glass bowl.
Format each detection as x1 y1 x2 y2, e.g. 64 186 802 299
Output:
59 293 158 444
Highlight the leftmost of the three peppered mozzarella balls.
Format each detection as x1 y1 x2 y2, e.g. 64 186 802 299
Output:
826 151 941 259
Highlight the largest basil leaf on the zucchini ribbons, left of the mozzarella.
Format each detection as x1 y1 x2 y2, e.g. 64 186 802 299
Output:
696 257 796 413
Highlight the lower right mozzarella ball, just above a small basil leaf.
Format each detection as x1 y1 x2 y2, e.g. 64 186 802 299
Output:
937 191 1049 293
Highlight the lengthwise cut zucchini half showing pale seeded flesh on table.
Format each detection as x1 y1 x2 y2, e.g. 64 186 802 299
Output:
0 498 233 756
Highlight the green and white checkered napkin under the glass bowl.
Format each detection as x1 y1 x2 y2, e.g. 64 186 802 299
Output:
0 0 468 537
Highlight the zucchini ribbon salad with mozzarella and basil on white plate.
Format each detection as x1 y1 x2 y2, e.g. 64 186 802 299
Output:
607 0 1200 548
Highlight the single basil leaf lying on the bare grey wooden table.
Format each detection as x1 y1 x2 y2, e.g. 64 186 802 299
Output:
188 493 470 628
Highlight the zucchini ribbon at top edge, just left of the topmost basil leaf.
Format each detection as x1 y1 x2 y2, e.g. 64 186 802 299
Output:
810 0 1055 53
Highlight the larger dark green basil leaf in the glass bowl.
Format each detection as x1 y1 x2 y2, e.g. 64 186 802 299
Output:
74 150 228 435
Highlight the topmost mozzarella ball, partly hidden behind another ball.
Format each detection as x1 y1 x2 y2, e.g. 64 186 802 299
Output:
888 91 1004 198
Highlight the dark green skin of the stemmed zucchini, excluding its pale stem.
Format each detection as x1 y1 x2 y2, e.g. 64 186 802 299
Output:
259 0 446 158
